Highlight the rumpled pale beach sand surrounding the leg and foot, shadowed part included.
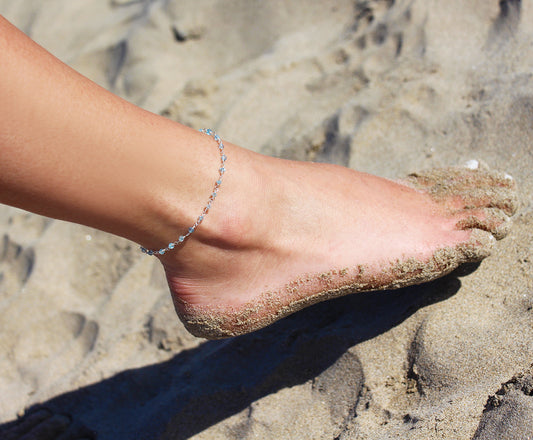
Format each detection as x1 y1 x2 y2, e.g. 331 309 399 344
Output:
0 0 533 440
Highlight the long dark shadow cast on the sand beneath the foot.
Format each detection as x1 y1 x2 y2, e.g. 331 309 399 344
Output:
0 266 466 440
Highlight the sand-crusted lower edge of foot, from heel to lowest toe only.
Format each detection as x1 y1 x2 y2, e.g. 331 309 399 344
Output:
176 223 496 339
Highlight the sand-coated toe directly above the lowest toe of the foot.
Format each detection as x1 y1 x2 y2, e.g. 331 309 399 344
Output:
455 208 511 240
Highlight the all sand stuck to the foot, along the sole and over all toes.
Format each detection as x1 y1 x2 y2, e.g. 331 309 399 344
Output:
175 162 518 339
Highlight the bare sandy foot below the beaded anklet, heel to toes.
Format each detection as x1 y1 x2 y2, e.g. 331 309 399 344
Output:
160 145 517 339
